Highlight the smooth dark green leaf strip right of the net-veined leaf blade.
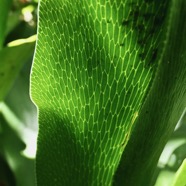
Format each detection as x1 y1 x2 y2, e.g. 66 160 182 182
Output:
115 0 186 186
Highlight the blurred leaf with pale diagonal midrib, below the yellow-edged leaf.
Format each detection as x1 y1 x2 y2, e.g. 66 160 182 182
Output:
0 59 37 186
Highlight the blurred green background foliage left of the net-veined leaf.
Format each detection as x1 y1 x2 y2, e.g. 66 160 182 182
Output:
0 0 37 186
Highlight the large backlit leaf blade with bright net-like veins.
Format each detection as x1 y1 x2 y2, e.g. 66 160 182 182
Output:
31 0 182 186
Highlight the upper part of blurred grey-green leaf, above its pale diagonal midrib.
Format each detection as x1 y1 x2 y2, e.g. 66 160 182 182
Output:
4 57 37 131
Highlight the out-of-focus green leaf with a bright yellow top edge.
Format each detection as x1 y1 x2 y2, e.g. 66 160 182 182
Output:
0 37 35 101
